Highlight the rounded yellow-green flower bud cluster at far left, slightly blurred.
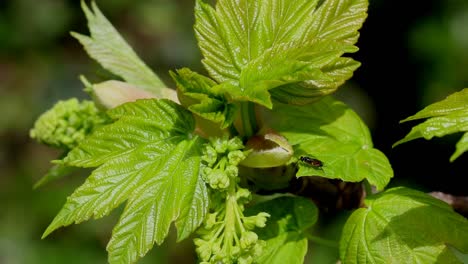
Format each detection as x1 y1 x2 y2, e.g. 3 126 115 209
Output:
30 98 108 149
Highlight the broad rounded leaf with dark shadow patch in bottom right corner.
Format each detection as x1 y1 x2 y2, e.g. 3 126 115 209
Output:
340 188 468 264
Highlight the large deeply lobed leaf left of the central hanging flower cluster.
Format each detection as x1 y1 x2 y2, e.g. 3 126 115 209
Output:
43 99 208 263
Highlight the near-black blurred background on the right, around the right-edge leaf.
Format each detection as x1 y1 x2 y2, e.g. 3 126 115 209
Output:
349 0 468 195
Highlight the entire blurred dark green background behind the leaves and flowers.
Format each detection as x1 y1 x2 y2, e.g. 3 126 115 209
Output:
0 0 468 264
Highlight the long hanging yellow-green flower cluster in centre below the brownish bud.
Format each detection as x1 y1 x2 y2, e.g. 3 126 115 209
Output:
194 138 270 264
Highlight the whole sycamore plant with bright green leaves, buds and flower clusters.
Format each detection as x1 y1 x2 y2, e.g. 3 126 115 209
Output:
30 0 468 263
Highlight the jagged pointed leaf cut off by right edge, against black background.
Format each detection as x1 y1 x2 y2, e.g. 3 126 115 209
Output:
393 88 468 161
